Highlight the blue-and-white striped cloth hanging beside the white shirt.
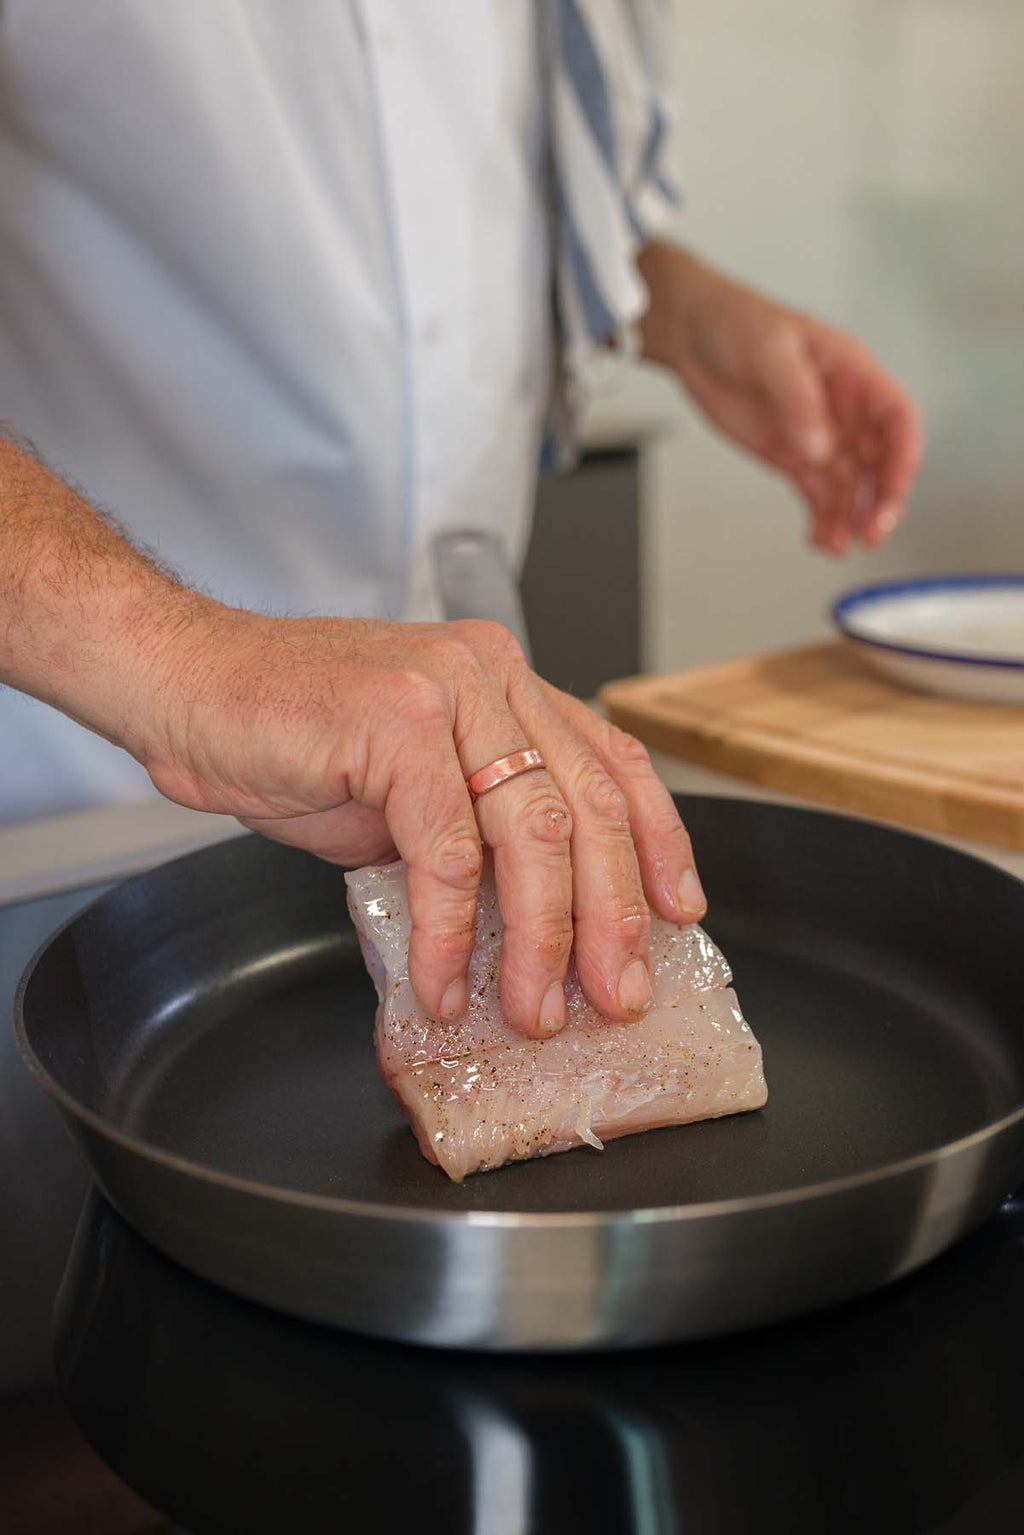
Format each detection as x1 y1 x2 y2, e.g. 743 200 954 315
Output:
540 0 679 464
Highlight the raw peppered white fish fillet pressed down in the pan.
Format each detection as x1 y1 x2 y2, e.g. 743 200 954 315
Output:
345 863 768 1182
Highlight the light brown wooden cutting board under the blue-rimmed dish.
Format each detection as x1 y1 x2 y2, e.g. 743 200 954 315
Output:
600 643 1024 849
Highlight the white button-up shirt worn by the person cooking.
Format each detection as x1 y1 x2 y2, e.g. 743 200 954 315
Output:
0 0 551 821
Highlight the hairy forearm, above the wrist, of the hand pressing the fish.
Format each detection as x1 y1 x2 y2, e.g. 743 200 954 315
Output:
0 437 213 754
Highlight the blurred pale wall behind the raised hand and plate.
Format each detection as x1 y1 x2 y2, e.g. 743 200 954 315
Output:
597 0 1024 669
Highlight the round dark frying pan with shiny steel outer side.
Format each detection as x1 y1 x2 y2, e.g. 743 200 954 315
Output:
15 798 1024 1349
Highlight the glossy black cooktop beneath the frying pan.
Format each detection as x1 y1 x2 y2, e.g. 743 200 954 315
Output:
0 892 1024 1535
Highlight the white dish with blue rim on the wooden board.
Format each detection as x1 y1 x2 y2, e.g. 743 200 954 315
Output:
832 574 1024 706
